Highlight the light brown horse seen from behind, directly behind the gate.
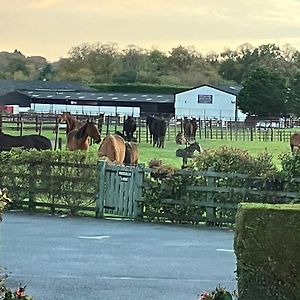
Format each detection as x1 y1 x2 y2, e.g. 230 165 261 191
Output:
98 134 126 164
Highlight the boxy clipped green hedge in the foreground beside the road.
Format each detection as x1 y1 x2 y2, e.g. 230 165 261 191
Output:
234 203 300 300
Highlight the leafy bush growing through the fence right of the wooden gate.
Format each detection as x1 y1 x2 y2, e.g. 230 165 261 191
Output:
143 147 282 223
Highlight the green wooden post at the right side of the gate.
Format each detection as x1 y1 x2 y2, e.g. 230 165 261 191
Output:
133 164 144 220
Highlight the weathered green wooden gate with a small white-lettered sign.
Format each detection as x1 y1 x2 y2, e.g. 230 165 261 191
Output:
96 161 144 219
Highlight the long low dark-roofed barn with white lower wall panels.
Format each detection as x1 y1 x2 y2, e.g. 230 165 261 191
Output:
0 80 174 117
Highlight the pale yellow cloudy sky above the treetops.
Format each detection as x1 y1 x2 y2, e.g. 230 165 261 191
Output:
0 0 300 62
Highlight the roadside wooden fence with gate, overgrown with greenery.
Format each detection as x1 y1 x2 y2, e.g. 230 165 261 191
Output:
0 160 300 224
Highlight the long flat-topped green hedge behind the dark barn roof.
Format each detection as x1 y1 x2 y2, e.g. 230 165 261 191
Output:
89 83 190 94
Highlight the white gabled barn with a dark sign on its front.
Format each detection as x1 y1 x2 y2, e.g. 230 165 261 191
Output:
175 84 246 121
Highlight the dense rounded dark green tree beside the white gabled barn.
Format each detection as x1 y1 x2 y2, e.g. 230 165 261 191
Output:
237 68 287 117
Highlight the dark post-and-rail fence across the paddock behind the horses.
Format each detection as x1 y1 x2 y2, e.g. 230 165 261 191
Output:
0 114 295 149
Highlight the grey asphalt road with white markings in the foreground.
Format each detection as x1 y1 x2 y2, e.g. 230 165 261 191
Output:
0 213 236 300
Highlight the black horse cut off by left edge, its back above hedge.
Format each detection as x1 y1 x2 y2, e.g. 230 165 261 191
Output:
0 133 52 151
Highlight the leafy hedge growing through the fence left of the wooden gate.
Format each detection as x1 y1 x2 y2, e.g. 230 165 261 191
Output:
0 150 98 213
